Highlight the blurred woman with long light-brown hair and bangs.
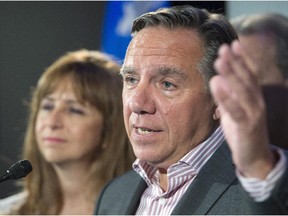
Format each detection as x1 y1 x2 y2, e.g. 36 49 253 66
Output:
0 50 134 215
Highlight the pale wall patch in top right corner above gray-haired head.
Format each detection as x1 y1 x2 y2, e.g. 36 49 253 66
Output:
226 1 288 19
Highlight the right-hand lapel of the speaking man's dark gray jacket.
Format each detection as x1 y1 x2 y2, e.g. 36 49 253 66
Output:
172 142 236 215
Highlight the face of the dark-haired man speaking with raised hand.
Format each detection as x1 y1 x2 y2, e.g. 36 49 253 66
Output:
122 27 214 169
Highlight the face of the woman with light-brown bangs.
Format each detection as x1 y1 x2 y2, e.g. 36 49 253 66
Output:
35 80 103 165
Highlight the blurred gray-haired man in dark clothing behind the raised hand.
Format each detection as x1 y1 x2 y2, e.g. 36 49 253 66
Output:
231 13 288 149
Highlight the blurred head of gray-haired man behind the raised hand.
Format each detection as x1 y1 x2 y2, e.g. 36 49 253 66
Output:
231 13 288 85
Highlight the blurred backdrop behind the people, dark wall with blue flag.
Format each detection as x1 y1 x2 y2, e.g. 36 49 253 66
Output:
0 1 288 198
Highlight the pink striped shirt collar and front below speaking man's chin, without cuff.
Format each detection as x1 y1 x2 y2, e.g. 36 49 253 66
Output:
133 128 224 215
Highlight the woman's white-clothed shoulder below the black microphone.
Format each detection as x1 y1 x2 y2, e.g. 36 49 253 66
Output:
0 192 28 214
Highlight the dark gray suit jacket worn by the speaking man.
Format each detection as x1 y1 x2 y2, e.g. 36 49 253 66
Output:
95 143 288 215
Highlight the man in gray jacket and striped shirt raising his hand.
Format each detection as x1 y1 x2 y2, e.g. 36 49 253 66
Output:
95 6 288 215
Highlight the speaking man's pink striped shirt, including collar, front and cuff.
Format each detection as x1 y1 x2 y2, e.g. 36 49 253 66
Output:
133 127 287 215
